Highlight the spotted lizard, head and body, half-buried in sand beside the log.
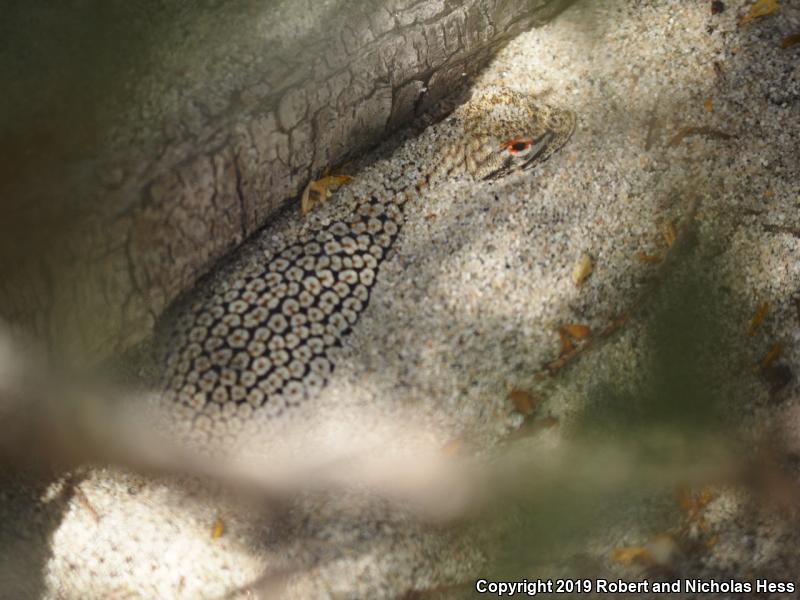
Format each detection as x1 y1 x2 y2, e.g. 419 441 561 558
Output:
164 88 575 442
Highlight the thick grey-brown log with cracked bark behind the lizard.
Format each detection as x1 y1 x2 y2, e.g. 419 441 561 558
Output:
0 0 570 362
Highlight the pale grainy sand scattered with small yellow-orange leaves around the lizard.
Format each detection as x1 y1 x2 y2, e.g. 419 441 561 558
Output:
0 0 800 599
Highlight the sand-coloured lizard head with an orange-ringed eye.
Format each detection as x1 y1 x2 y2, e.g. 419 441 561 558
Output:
438 87 575 180
